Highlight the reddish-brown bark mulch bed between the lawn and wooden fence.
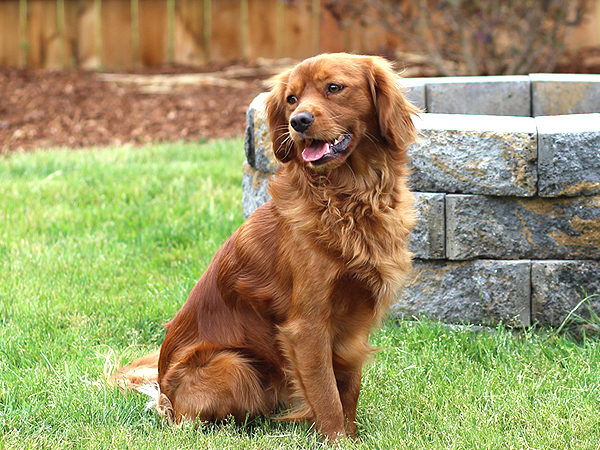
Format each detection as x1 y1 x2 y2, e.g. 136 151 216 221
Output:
0 63 268 153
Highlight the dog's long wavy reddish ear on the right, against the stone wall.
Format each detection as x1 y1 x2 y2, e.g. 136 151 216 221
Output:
367 57 420 149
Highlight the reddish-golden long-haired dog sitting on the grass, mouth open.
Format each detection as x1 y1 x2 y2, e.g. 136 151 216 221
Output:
113 54 418 441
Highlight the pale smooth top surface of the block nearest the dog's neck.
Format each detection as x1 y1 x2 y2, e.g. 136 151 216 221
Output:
414 113 537 133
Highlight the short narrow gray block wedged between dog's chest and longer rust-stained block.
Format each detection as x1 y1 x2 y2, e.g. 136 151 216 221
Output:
409 192 446 259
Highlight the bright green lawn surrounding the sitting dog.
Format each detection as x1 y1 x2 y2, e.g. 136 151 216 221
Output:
0 140 600 450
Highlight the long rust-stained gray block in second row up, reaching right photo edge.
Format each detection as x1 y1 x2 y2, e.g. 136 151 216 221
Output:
446 195 600 260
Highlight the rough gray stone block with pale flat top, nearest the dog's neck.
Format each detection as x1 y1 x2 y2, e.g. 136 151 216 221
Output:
409 114 537 196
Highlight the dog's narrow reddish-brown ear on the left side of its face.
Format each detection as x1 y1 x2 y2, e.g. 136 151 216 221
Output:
265 70 294 162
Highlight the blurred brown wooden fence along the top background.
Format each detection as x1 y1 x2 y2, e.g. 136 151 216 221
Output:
0 0 600 69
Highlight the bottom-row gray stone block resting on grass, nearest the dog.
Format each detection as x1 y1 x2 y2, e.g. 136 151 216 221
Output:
392 260 531 326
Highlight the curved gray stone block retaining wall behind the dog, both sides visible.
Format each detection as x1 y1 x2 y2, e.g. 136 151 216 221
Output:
242 74 600 326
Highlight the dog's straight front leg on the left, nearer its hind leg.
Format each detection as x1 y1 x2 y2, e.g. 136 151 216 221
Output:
280 319 346 441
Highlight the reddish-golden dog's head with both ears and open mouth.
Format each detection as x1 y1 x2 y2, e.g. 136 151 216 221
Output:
266 53 418 170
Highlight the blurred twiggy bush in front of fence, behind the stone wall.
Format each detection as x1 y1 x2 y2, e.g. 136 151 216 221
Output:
325 0 589 76
